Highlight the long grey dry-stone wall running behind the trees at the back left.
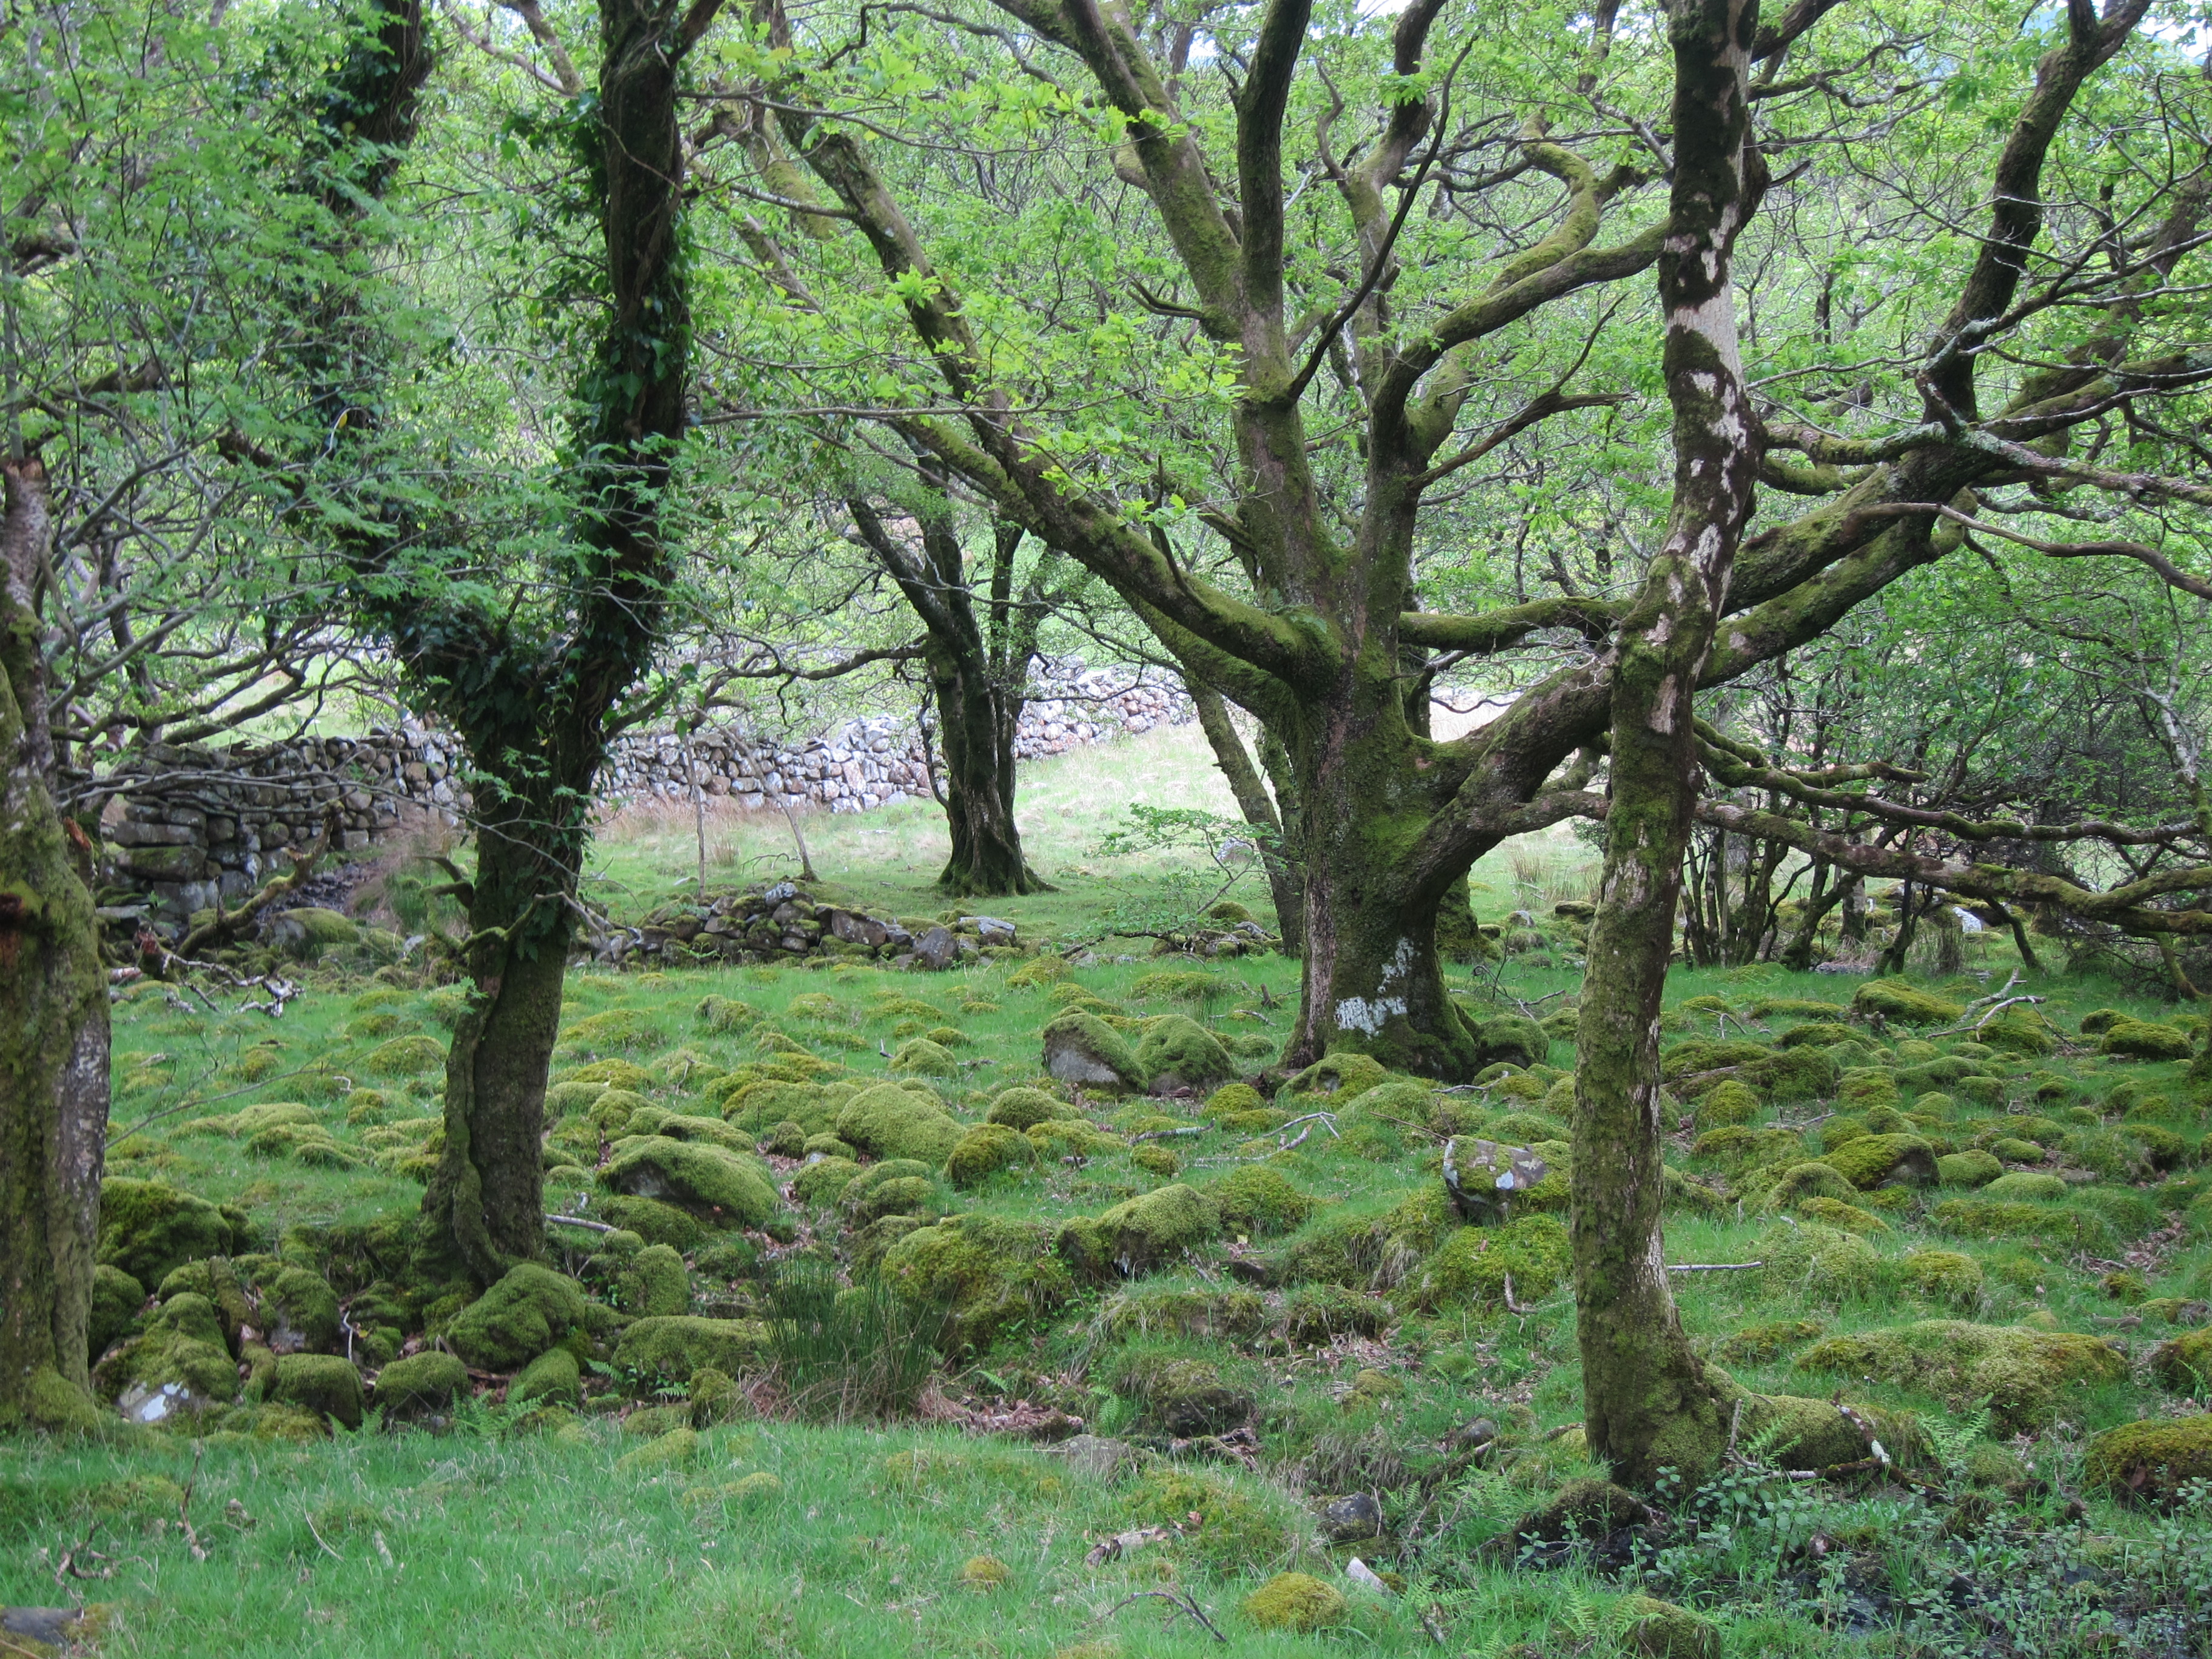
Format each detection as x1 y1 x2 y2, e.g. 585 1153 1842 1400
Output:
79 662 1192 916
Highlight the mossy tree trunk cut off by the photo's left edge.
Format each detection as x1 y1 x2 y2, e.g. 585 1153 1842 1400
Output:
0 455 109 1429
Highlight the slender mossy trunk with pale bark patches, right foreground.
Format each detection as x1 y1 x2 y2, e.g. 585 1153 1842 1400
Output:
1570 0 1761 1486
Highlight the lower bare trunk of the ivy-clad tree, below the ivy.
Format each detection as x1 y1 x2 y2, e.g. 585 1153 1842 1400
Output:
423 803 581 1285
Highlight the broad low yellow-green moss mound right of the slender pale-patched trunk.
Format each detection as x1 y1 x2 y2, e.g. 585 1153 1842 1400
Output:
1798 1318 2128 1433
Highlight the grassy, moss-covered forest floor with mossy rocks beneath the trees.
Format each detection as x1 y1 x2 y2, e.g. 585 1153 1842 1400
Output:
0 732 2212 1659
